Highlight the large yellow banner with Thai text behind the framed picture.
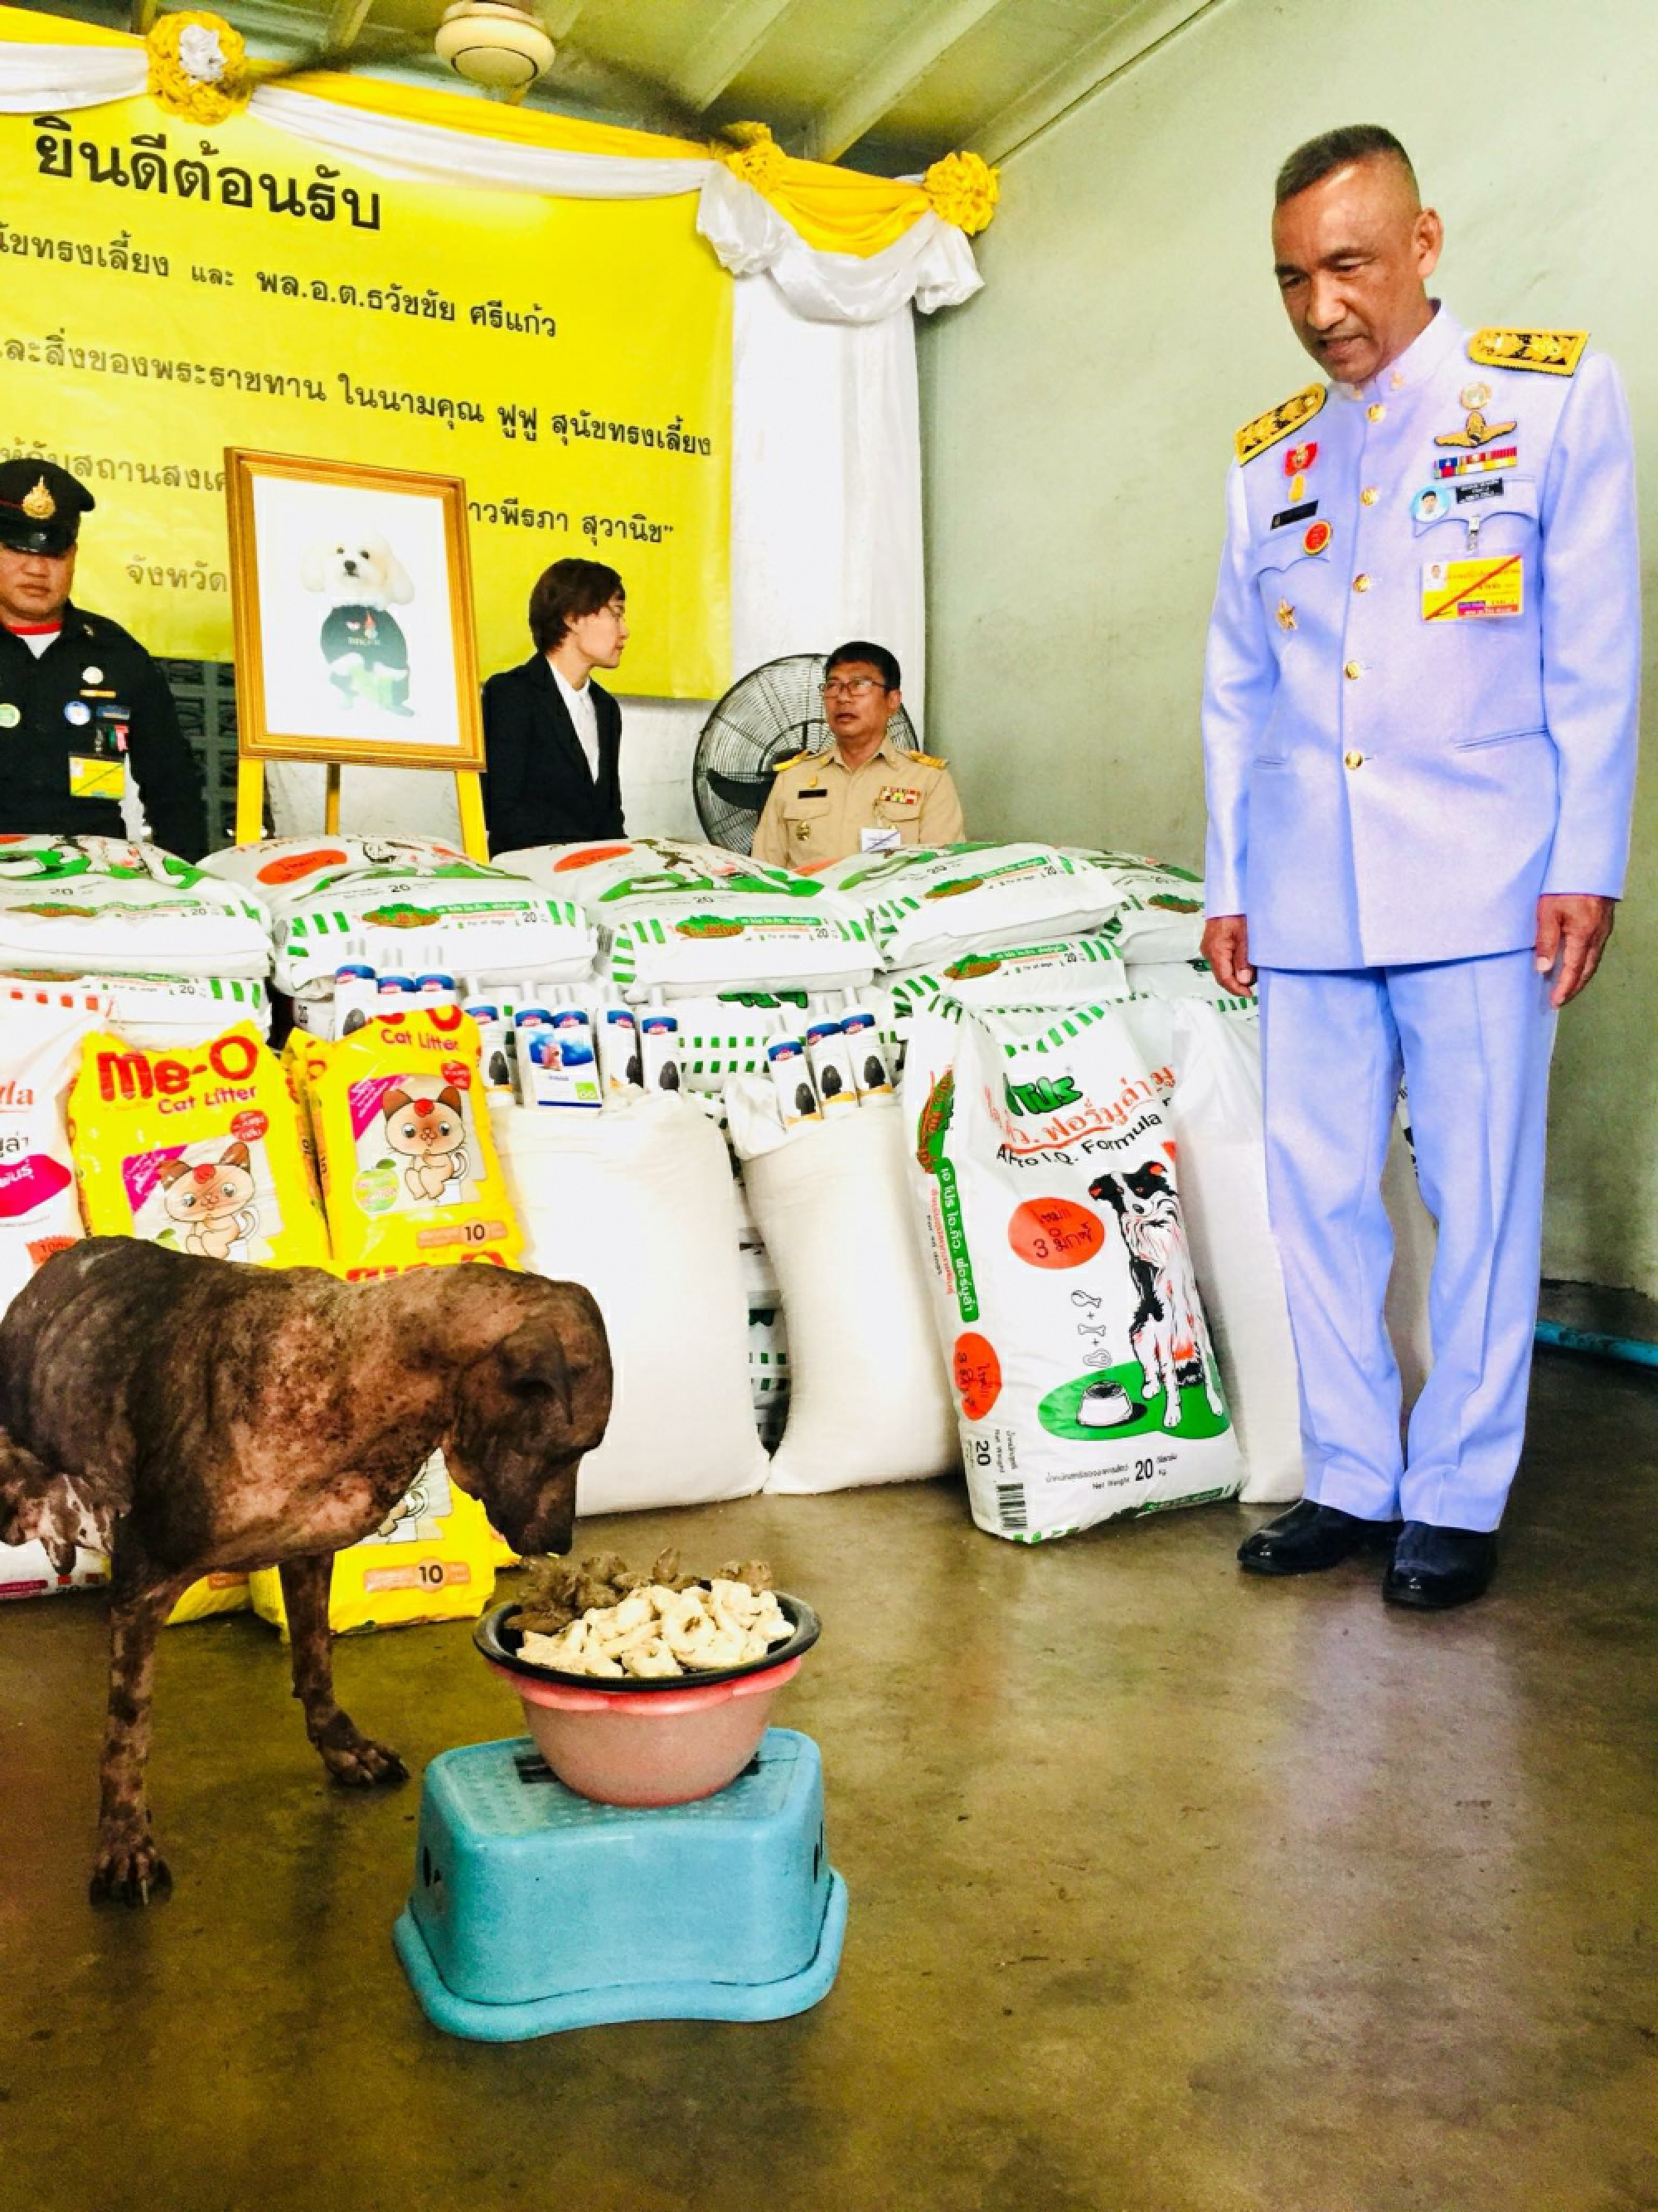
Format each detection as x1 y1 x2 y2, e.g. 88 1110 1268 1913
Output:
0 97 732 699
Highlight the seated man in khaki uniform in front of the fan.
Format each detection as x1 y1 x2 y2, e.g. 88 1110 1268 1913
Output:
754 639 966 874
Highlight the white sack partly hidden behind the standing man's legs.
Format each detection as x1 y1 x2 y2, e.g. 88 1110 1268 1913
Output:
1125 997 1437 1504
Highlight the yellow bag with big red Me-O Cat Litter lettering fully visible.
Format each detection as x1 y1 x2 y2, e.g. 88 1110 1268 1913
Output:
69 1022 327 1268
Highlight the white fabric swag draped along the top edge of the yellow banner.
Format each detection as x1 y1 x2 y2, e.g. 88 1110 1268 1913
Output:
0 44 984 323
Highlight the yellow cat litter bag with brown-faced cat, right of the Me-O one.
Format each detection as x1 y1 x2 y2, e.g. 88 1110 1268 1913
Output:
298 1004 524 1281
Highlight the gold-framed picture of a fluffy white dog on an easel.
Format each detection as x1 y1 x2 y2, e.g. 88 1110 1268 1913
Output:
225 447 484 769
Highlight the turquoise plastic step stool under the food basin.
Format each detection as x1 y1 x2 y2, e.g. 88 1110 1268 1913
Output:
391 1728 846 2044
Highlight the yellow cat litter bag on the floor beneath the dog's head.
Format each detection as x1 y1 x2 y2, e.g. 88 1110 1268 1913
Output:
252 1453 495 1643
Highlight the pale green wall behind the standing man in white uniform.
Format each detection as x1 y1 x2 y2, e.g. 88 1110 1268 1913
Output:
922 0 1658 1292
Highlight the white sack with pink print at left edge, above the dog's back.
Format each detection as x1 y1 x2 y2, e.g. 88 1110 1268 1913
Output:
0 991 104 1318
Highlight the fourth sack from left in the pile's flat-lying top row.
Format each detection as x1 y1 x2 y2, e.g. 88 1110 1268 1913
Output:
816 845 1121 969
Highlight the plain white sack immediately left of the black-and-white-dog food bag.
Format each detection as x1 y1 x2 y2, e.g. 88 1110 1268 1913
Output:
725 1077 957 1496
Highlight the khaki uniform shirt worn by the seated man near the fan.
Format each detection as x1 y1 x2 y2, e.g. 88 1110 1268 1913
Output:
754 736 966 870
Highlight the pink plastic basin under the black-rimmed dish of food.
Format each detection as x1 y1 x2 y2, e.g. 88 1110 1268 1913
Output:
488 1659 800 1805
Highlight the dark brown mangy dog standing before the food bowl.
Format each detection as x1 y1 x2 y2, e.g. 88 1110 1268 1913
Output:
0 1236 610 1904
